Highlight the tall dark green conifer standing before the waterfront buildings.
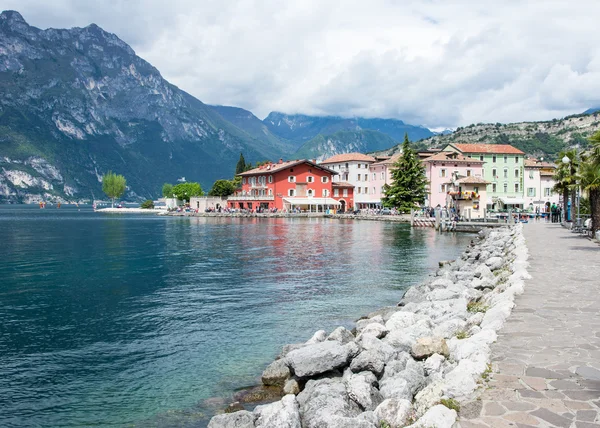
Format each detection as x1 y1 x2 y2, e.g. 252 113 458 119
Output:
382 134 428 212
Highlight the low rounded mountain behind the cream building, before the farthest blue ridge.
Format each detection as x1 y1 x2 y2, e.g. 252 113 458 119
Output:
294 129 398 160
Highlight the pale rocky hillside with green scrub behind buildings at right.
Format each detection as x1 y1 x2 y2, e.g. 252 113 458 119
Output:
374 112 600 159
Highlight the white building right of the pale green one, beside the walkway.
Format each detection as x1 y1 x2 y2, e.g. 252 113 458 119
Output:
524 159 559 212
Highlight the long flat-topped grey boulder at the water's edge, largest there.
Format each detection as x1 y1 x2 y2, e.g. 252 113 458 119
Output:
285 340 359 377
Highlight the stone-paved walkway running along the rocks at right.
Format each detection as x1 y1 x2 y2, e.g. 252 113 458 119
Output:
459 223 600 428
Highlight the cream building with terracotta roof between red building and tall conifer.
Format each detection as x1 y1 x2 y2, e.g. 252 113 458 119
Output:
320 153 381 209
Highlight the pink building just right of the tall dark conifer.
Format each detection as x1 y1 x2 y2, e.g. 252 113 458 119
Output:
422 151 487 211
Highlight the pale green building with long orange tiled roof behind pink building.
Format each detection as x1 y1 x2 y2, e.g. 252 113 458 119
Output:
443 143 525 209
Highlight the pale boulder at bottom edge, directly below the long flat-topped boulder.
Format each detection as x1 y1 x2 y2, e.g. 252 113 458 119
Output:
297 378 361 428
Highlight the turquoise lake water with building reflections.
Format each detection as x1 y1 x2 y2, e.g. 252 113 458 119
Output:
0 206 472 427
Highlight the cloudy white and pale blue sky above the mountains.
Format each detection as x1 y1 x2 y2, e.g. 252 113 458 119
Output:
0 0 600 129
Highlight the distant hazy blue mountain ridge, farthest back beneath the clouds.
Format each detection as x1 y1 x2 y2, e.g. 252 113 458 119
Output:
263 112 434 147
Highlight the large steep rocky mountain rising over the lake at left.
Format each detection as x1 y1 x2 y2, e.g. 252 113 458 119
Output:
0 11 291 202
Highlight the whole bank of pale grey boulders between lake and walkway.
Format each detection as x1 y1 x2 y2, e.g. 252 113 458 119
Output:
209 225 528 428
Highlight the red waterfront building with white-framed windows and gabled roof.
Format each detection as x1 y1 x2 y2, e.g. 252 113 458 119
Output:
227 159 354 212
